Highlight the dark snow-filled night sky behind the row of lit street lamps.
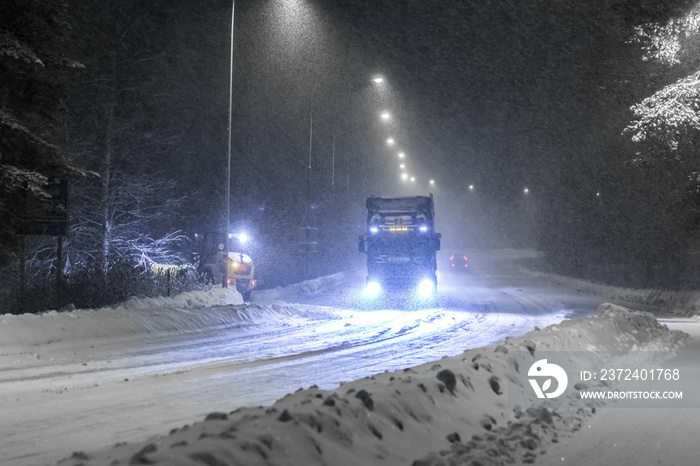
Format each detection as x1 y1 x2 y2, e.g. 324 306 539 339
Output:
201 0 644 248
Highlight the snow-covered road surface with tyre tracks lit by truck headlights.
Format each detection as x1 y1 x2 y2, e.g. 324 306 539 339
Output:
0 254 601 466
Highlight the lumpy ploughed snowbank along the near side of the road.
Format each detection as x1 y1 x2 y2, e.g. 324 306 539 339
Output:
60 304 685 466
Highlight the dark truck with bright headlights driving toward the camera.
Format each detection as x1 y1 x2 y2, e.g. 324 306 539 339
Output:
359 194 441 296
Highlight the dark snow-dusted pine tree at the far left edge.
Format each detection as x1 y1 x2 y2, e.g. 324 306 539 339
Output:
0 0 86 265
